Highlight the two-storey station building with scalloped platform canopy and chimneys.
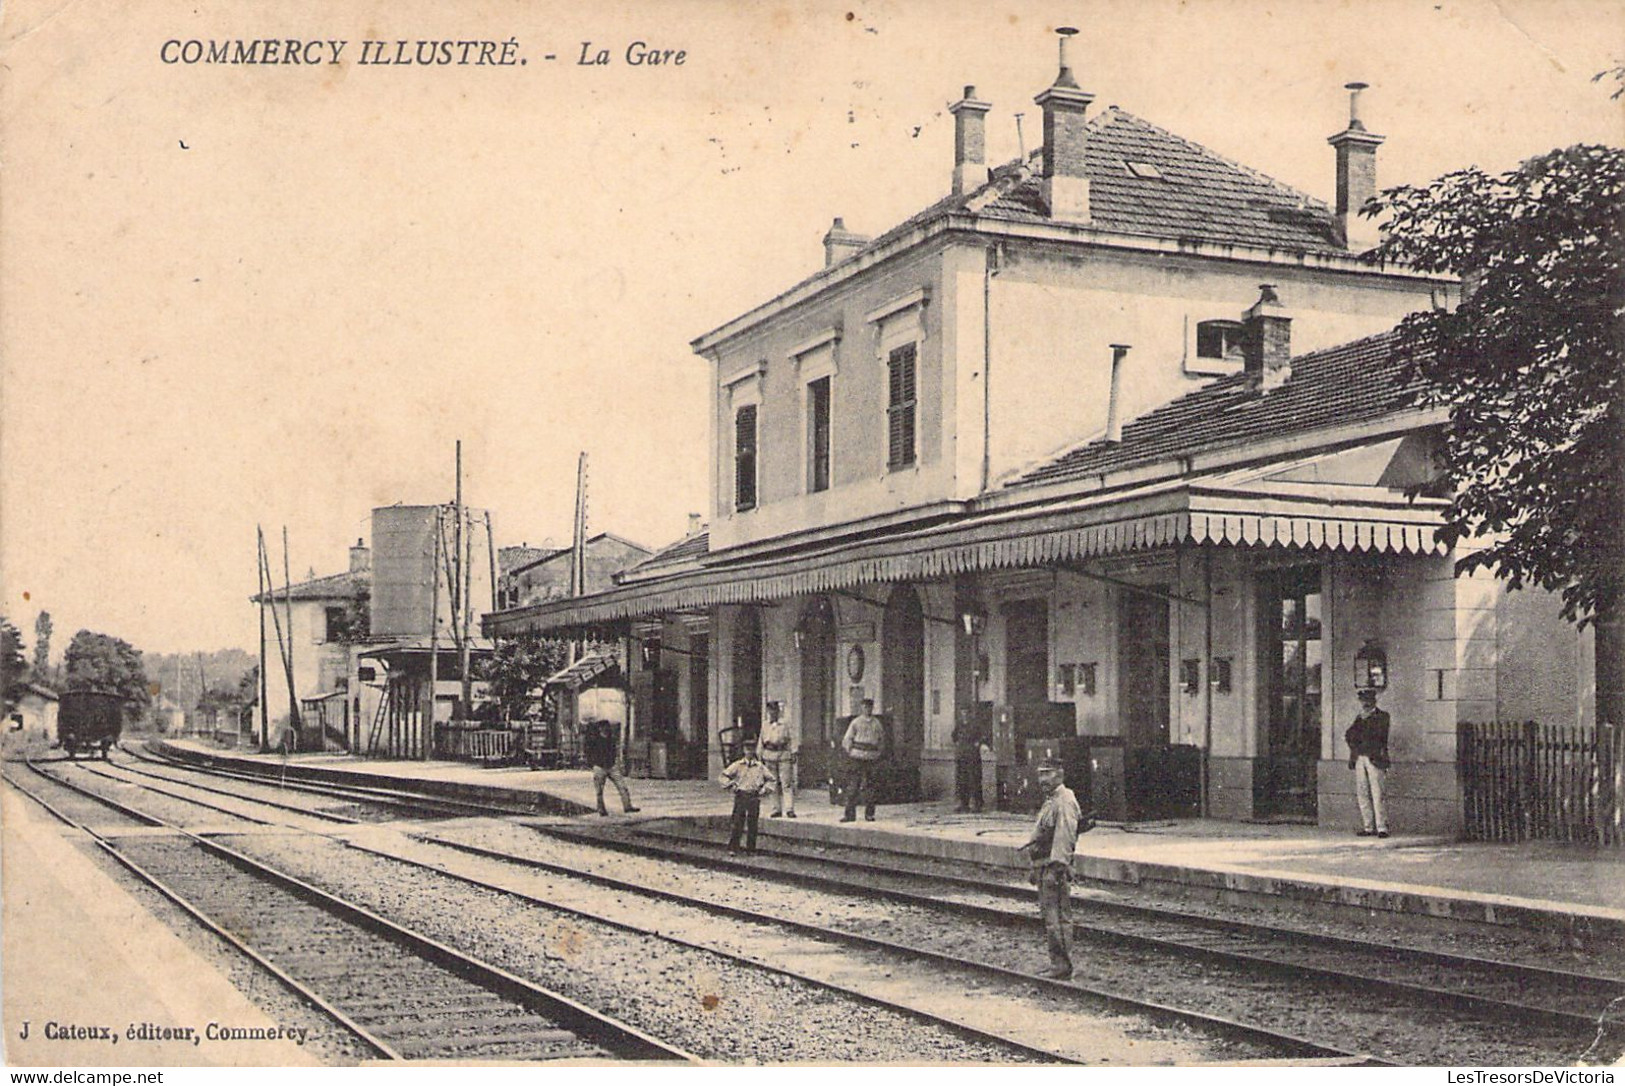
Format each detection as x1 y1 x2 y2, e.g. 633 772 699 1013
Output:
486 41 1586 831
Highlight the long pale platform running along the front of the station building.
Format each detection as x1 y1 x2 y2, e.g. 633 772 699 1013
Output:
155 740 1625 938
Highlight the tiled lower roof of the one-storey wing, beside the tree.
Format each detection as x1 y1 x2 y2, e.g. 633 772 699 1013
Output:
1006 332 1420 488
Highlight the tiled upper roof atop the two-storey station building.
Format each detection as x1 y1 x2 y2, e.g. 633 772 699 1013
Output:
871 106 1347 254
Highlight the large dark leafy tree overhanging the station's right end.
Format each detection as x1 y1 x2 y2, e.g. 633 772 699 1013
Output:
1367 139 1625 723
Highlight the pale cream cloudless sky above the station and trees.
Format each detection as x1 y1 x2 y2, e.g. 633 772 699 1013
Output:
0 0 1625 655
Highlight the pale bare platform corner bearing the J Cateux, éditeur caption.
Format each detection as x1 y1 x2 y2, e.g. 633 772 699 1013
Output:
0 777 320 1066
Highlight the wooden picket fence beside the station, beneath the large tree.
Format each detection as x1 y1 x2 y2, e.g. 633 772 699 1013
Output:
1456 720 1625 847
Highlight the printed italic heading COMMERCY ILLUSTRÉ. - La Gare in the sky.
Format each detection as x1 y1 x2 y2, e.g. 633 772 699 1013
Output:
158 37 689 68
